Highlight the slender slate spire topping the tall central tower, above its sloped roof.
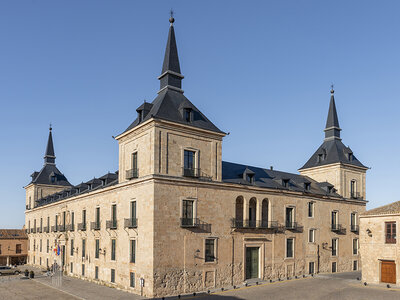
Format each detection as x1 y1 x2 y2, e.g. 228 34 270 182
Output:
158 15 183 93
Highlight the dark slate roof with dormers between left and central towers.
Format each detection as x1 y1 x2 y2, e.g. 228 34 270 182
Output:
36 171 118 207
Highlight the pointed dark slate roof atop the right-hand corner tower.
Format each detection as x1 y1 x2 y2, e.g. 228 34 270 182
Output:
300 88 368 170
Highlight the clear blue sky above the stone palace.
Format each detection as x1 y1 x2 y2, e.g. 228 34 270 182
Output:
0 0 400 228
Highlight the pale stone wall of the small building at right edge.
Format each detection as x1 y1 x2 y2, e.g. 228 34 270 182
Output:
360 208 400 285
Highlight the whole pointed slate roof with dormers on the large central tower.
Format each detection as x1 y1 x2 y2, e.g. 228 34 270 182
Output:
122 17 225 134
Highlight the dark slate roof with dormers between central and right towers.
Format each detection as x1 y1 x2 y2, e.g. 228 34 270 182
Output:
222 161 341 197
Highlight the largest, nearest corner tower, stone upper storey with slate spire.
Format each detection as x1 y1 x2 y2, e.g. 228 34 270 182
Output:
116 17 225 182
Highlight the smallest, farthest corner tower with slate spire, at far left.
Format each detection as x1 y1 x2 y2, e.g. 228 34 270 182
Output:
25 126 71 209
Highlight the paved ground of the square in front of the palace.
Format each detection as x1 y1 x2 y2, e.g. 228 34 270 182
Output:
0 272 400 300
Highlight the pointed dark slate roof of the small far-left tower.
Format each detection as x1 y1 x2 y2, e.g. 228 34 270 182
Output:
31 125 71 186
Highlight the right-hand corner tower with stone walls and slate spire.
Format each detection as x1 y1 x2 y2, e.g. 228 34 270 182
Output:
299 87 368 199
